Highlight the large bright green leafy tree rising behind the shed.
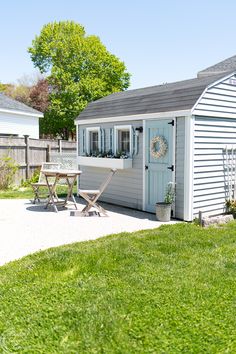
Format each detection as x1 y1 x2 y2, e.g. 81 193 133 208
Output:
29 21 130 138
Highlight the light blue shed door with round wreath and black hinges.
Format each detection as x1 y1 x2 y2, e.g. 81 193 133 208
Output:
145 120 174 212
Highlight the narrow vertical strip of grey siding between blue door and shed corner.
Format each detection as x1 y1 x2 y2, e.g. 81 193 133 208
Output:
175 117 185 220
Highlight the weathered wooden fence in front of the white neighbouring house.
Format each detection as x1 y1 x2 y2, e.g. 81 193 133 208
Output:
0 136 76 183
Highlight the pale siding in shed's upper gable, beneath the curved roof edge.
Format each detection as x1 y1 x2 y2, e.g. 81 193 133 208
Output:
193 75 236 118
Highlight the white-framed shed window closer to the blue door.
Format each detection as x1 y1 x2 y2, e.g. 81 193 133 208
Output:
115 125 132 156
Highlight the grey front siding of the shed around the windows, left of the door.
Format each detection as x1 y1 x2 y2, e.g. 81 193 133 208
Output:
79 120 143 210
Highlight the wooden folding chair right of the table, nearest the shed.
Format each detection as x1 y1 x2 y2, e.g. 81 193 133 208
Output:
78 169 116 216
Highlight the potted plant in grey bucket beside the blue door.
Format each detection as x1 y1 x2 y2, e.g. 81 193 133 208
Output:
156 182 175 222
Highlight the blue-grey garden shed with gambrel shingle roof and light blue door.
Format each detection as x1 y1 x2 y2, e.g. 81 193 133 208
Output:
75 56 236 221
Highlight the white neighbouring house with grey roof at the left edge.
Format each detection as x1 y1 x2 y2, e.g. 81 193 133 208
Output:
0 93 43 139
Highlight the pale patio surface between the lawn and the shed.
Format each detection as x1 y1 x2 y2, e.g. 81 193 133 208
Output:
0 199 176 265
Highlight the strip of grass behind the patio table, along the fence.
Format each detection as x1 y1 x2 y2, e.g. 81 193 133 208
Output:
0 186 76 199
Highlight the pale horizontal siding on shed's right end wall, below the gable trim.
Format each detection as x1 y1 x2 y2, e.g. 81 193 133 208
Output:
193 117 236 217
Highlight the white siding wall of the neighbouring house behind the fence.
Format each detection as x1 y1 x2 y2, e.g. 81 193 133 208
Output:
0 112 39 139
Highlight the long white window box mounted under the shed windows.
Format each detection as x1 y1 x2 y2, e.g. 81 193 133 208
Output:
78 156 133 170
